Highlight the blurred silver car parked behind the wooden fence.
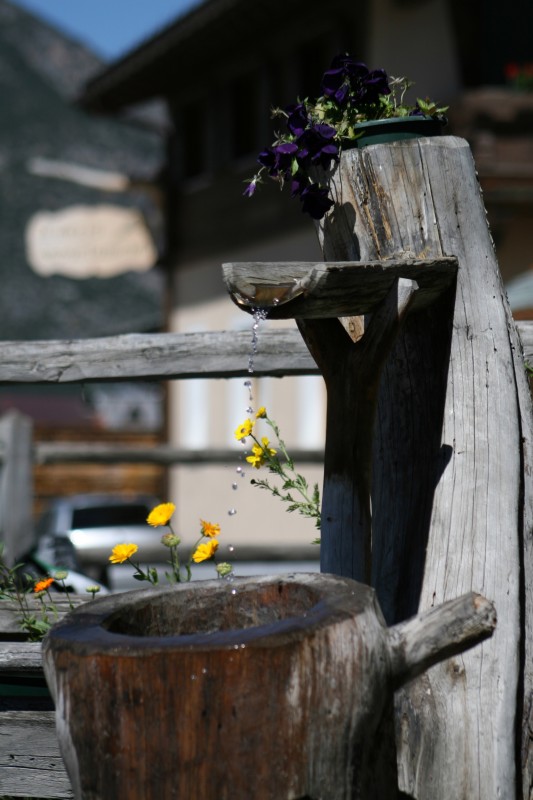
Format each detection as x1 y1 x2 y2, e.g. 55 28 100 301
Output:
36 494 162 582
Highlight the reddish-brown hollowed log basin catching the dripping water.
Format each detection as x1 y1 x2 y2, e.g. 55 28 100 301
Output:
43 574 494 800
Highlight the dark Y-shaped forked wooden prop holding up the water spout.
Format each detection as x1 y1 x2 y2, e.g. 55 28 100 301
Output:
298 278 418 584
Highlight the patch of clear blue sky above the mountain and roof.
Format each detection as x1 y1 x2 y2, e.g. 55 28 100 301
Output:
10 0 202 60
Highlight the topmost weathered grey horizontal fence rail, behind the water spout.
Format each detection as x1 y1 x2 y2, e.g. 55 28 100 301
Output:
0 321 533 384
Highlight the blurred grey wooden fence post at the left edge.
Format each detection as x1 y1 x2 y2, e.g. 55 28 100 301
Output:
0 411 33 564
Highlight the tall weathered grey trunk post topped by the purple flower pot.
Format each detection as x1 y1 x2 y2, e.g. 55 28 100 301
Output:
314 137 533 800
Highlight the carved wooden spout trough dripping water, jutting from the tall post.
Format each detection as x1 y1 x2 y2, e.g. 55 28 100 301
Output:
222 256 457 319
